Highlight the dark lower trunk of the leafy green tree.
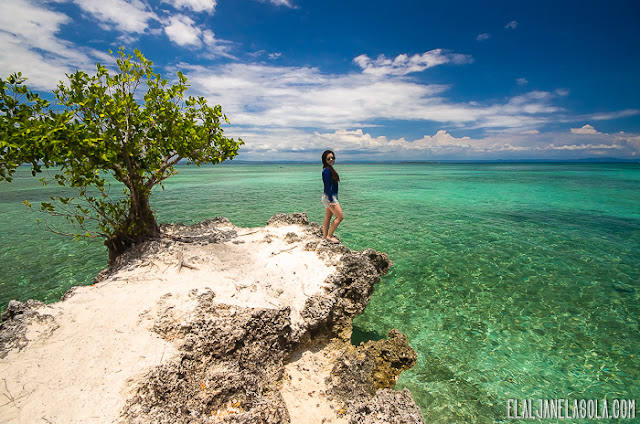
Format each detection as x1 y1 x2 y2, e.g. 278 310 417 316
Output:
104 190 160 266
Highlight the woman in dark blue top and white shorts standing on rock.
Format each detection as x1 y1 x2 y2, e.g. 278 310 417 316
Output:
322 150 344 243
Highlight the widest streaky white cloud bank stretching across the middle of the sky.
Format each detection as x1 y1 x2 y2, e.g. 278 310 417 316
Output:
179 58 596 133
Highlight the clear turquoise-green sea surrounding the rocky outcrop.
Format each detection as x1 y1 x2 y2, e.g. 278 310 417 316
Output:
0 163 640 423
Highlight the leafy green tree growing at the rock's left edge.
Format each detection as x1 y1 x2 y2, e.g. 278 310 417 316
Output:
0 48 244 263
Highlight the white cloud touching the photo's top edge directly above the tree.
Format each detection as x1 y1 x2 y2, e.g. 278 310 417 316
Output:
74 0 158 33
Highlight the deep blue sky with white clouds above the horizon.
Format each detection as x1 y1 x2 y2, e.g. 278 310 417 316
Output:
0 0 640 163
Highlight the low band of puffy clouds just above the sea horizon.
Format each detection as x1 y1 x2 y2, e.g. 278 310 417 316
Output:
225 128 640 160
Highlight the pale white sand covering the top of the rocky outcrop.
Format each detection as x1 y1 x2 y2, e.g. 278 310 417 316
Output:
0 224 343 424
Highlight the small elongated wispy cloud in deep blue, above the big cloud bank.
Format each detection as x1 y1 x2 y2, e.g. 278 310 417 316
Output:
353 49 472 76
